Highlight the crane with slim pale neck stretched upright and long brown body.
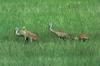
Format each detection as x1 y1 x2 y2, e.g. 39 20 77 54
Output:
49 23 70 39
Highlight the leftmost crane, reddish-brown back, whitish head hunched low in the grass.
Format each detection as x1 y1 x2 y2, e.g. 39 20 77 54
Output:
16 27 38 42
